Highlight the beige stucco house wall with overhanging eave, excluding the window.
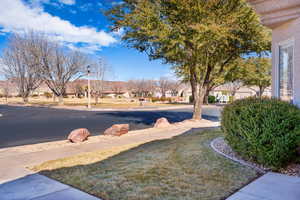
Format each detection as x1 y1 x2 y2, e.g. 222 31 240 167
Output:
248 0 300 106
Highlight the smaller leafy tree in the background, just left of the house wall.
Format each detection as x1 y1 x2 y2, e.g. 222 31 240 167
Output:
243 57 272 97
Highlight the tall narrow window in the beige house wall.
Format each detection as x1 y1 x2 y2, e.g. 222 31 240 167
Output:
279 44 294 102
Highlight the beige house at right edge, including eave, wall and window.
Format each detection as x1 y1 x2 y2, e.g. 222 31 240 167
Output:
248 0 300 106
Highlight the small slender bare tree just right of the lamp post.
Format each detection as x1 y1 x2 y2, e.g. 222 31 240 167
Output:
91 58 111 104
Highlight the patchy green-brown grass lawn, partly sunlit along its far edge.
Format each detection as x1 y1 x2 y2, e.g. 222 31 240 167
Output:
33 130 259 200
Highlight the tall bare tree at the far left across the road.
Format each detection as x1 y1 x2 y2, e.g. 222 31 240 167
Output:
1 32 41 103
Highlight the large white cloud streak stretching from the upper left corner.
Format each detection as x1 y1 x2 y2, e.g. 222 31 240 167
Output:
0 0 116 52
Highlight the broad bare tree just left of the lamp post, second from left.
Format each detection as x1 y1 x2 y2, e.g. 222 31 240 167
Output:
40 39 87 104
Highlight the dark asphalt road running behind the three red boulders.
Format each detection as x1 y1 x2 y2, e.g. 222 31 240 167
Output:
0 105 220 148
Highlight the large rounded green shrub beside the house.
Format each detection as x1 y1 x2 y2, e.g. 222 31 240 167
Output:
221 97 300 169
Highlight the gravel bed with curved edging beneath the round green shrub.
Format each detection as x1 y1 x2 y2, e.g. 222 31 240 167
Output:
211 137 300 177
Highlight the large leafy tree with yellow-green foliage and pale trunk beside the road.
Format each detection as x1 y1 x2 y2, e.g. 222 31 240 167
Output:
107 0 270 119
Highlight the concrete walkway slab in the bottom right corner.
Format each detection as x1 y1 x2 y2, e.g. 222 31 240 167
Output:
226 172 300 200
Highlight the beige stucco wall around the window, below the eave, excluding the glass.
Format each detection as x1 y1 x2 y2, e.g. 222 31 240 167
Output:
272 18 300 106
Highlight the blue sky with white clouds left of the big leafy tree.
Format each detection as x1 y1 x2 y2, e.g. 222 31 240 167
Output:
0 0 172 81
